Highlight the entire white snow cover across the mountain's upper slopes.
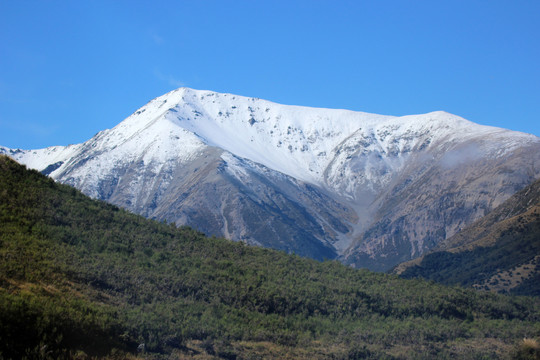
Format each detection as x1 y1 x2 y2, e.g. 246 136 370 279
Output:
0 88 538 197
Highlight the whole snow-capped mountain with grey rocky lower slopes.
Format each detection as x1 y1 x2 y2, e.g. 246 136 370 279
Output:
4 88 540 270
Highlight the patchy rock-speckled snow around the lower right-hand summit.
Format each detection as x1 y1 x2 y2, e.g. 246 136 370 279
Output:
324 111 539 200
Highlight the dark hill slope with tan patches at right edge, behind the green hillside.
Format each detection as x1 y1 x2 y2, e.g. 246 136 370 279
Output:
396 180 540 296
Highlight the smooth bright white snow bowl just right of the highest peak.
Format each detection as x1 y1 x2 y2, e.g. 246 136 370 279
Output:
161 88 396 183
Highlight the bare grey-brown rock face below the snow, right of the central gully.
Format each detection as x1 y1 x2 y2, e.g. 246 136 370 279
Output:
344 140 539 271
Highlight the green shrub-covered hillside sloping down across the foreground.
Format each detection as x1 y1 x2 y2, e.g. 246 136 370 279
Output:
0 157 540 359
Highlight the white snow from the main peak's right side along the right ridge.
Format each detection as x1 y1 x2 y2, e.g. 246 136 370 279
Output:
156 88 538 196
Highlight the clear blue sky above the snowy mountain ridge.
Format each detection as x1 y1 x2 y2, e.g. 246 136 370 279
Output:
0 0 540 149
